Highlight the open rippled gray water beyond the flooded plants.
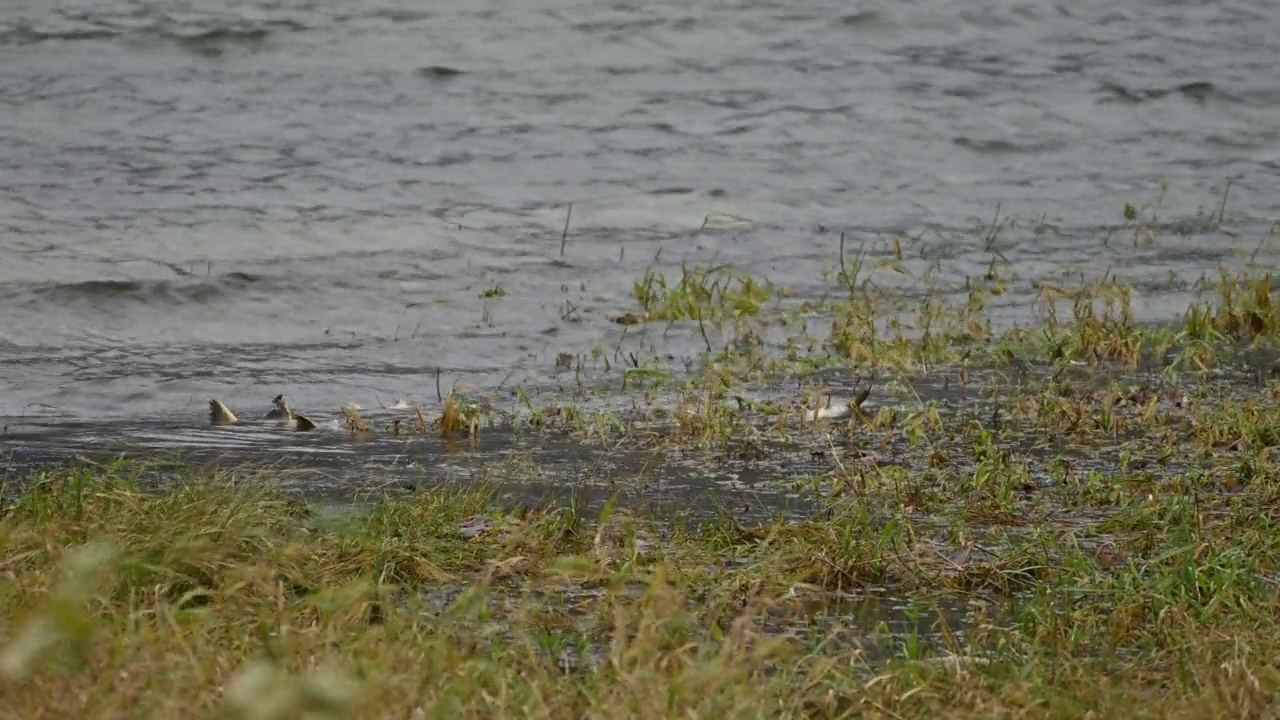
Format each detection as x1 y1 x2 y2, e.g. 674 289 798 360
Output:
0 0 1280 458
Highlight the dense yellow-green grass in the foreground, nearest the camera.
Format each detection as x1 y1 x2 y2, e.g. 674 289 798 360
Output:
0 450 1280 719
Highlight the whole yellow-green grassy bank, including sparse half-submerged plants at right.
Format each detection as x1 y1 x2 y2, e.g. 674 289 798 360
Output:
0 251 1280 717
